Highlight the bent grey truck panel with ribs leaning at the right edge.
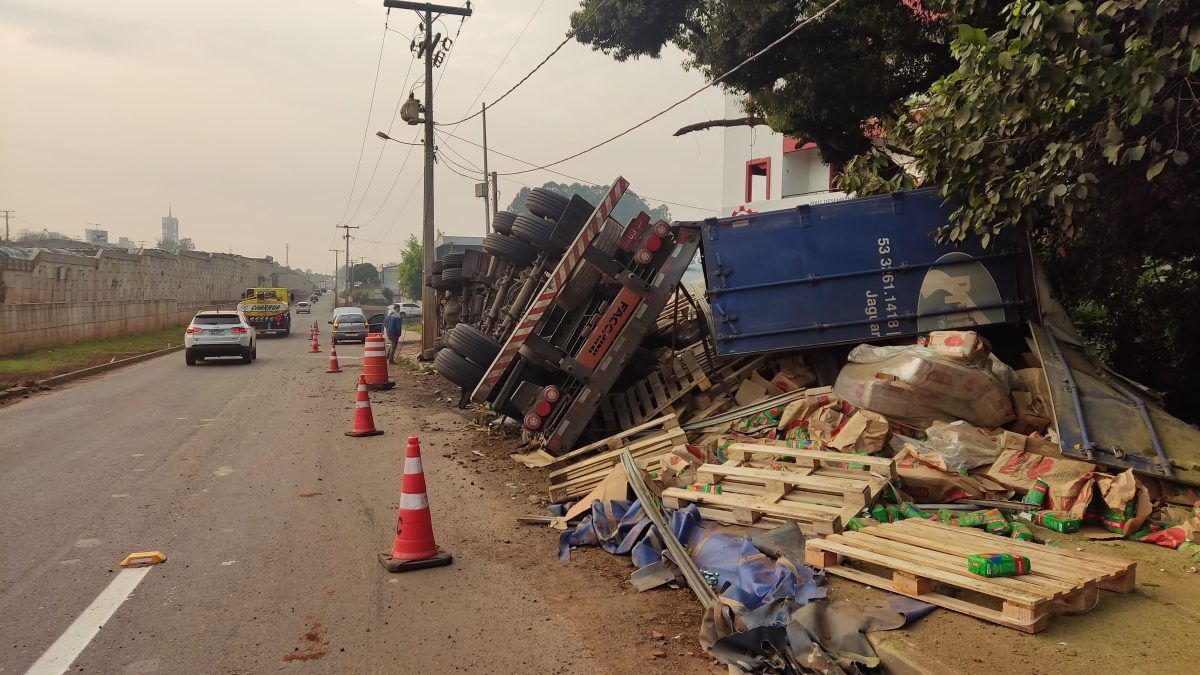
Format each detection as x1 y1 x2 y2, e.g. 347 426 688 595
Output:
1030 323 1200 485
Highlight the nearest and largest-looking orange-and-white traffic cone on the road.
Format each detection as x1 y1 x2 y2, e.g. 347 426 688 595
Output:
379 436 454 572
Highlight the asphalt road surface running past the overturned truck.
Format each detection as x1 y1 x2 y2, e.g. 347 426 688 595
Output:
0 317 606 673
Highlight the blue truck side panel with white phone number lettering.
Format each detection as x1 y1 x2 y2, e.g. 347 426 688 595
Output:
702 189 1022 356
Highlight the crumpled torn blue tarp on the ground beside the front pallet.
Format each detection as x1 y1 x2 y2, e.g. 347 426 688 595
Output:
558 501 824 609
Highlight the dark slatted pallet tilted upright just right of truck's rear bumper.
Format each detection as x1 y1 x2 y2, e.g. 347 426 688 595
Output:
600 351 710 429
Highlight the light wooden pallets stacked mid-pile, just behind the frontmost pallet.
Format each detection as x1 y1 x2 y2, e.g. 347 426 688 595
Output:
662 443 895 534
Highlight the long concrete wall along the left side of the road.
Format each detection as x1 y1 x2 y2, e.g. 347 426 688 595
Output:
0 247 313 356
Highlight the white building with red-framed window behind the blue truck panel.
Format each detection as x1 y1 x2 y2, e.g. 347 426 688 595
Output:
721 95 846 216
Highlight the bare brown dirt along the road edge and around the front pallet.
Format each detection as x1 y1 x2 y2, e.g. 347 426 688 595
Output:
400 355 1200 674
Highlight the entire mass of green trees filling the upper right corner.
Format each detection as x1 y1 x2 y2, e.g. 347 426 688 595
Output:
571 0 1200 420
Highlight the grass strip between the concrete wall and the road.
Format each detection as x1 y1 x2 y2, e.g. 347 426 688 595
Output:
0 324 185 388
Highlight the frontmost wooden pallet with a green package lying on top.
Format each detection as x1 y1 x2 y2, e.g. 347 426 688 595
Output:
804 519 1136 633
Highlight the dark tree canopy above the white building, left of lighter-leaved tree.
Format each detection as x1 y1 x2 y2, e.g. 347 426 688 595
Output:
571 0 954 165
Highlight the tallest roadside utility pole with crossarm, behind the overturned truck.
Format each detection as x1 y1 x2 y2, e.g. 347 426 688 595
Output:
383 0 472 351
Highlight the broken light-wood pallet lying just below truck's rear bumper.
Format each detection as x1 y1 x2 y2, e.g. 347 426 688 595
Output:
550 414 688 502
